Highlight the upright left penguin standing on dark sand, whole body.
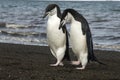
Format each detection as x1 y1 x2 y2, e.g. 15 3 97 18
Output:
43 4 70 66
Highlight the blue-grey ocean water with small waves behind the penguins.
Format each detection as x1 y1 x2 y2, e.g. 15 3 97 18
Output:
0 0 120 51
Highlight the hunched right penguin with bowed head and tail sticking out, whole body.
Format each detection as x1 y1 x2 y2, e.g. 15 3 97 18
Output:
59 9 103 69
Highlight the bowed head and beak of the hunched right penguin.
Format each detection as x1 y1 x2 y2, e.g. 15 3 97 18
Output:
59 9 73 29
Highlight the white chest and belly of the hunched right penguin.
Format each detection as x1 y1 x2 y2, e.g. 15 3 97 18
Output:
70 21 87 54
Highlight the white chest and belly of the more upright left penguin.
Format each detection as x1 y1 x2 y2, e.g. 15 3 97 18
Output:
47 15 66 49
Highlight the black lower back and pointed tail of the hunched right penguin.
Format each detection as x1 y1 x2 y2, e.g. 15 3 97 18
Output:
86 28 106 65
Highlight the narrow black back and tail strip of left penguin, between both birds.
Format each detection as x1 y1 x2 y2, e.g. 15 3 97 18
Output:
63 26 71 61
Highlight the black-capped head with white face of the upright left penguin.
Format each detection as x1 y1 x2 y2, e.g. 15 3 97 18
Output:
43 4 61 18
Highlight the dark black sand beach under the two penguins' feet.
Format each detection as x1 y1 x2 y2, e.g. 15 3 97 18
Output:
0 43 120 80
